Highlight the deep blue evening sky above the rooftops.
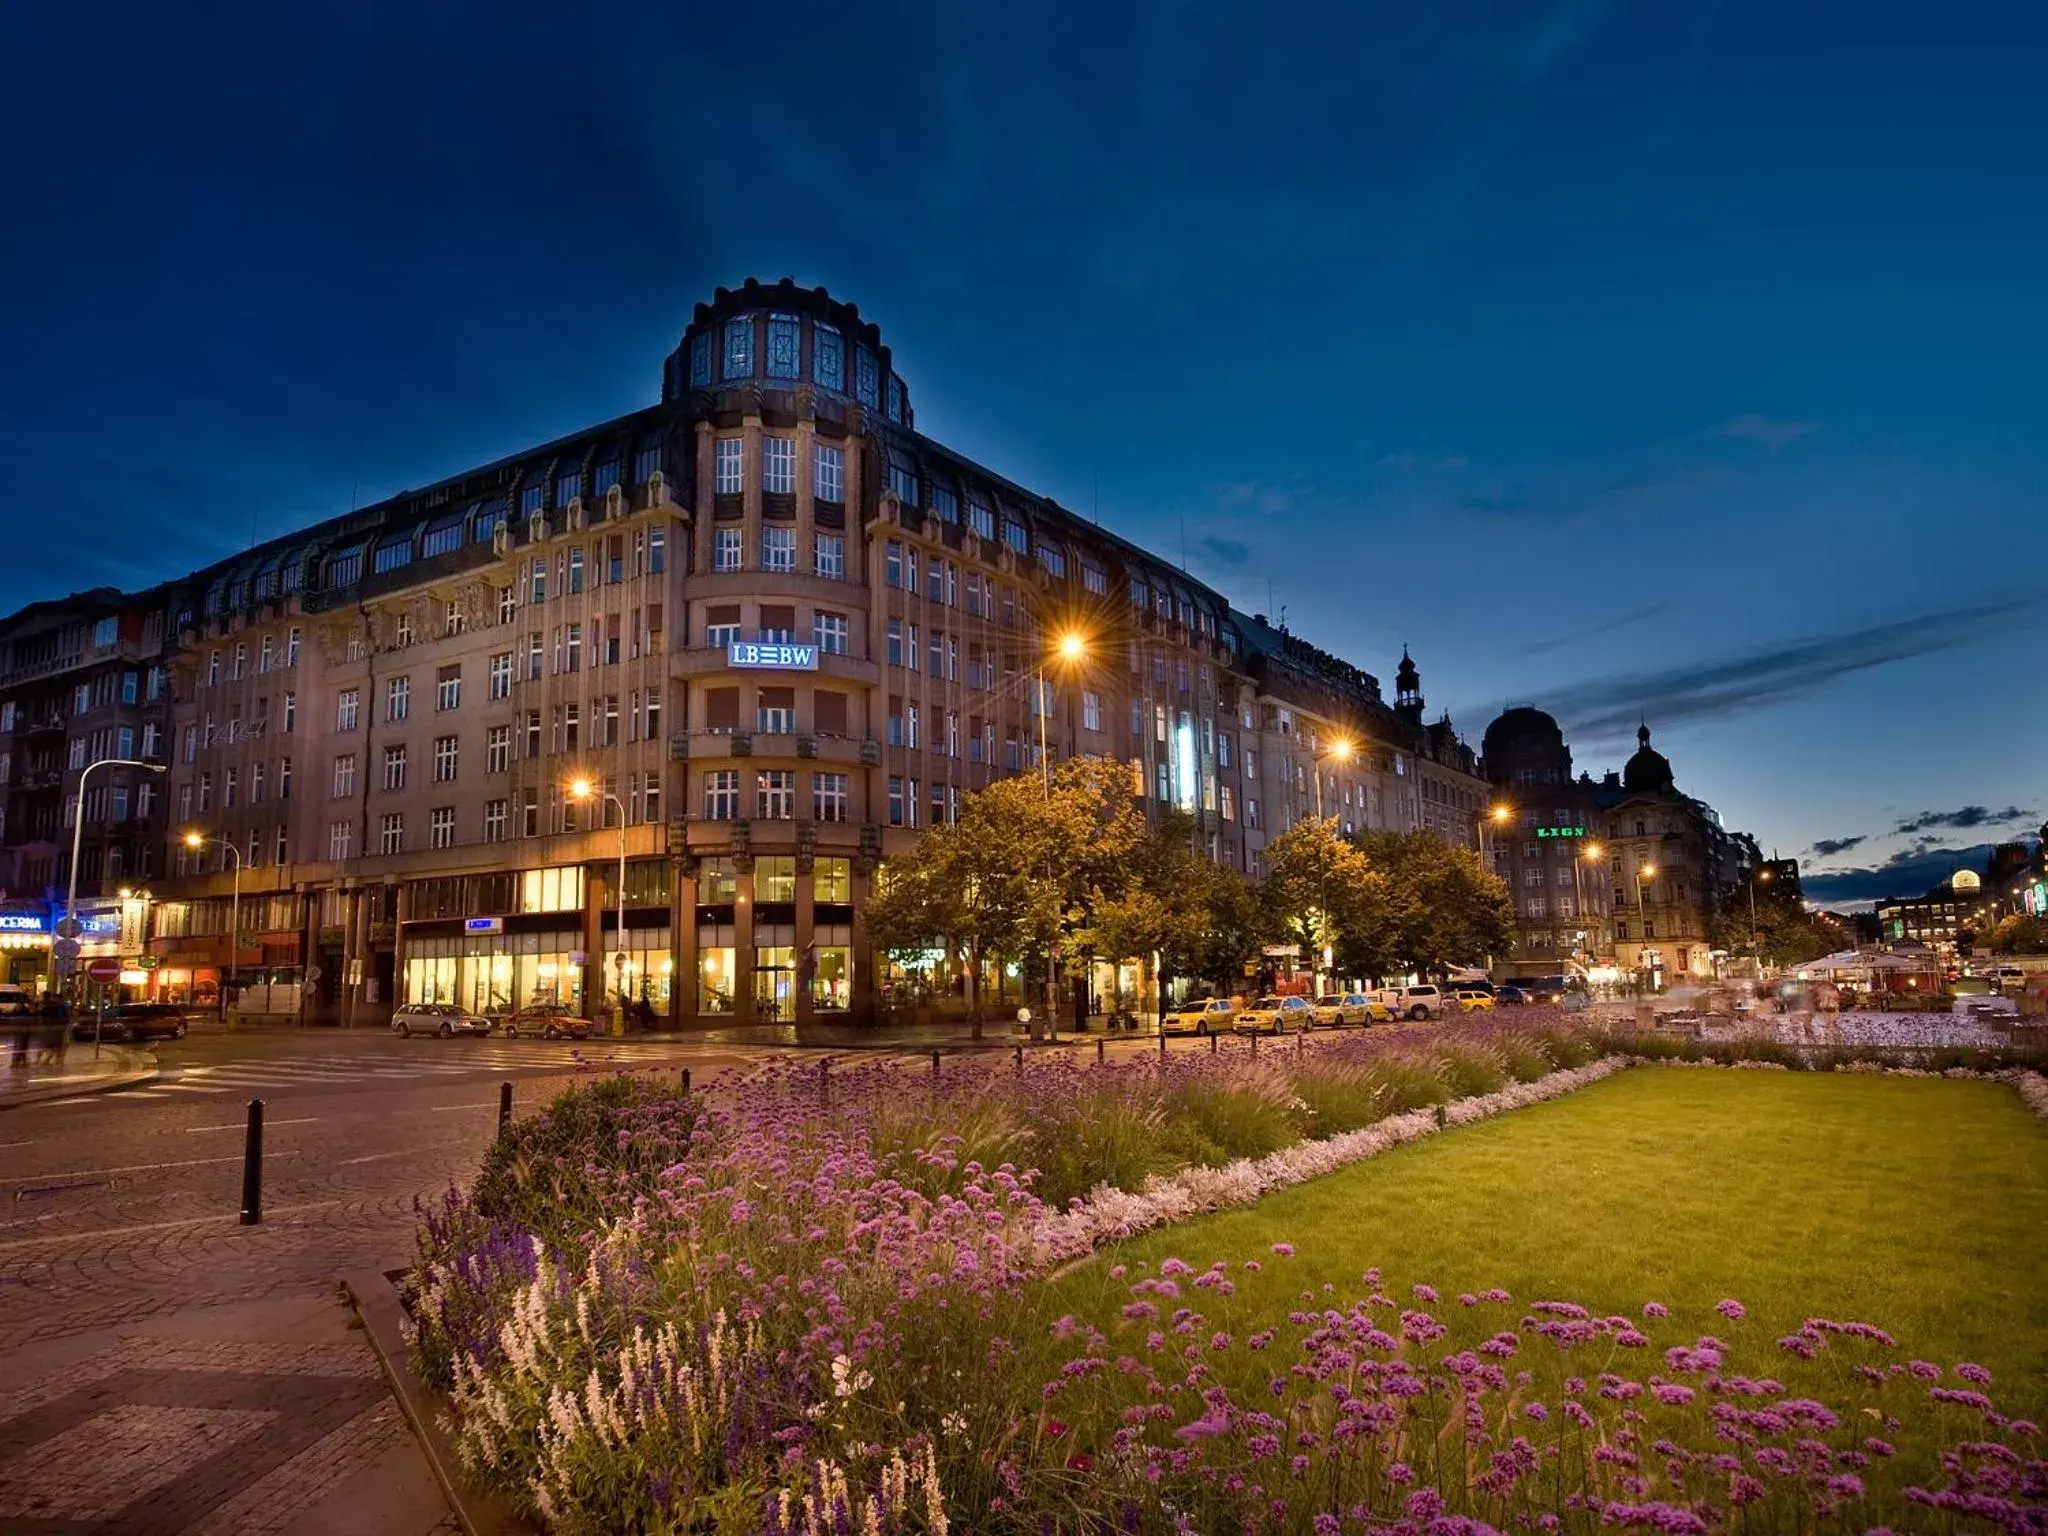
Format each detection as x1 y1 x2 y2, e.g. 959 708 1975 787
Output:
0 0 2048 897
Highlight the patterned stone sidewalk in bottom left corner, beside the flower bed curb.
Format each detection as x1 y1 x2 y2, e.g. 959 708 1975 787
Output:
0 1286 459 1536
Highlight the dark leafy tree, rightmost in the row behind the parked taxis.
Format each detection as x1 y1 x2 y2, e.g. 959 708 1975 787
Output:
1354 831 1516 977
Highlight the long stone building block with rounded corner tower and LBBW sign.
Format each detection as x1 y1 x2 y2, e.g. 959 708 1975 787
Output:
0 281 1485 1024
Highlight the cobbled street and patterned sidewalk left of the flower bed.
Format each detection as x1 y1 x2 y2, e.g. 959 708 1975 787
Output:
0 1032 774 1536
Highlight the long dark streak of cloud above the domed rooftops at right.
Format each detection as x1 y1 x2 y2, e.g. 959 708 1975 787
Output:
1550 596 2042 743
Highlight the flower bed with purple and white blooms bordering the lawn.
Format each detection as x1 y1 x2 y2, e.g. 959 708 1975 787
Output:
416 1020 2042 1536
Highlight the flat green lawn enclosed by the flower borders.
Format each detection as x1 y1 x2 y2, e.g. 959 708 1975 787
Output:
1044 1069 2048 1419
